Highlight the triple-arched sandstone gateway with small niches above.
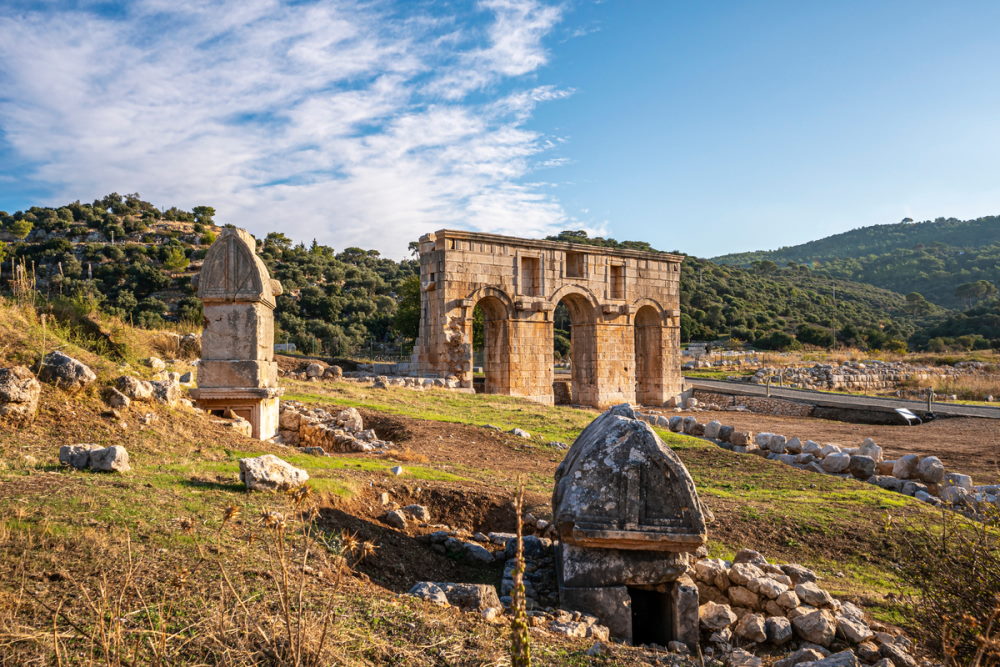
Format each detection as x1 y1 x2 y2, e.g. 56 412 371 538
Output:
414 230 682 407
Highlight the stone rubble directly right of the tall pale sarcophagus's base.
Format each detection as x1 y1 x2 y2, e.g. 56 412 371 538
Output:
278 401 393 454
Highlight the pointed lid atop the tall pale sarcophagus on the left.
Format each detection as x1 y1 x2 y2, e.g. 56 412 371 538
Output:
198 227 281 308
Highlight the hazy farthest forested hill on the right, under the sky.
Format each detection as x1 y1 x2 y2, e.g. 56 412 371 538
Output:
714 216 1000 308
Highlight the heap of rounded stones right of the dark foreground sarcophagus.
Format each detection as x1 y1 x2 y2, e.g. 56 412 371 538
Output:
692 549 916 667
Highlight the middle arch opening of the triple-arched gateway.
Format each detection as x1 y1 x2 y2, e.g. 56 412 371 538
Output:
552 294 597 405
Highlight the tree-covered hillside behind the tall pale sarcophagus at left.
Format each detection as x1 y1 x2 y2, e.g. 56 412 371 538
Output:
0 193 416 354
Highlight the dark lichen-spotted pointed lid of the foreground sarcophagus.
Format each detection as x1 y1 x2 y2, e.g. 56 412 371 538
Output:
552 405 706 551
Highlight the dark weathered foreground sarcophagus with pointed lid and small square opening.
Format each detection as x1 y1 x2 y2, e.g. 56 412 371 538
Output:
552 405 706 648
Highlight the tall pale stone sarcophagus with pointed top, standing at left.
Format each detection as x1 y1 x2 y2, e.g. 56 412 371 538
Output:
191 227 283 440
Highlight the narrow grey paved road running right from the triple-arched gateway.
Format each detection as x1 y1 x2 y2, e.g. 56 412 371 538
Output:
684 377 1000 419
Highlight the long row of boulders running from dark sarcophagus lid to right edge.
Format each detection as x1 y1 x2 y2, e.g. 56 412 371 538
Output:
642 414 1000 518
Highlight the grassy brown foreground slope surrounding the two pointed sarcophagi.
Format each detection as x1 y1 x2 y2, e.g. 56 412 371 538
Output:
0 302 992 665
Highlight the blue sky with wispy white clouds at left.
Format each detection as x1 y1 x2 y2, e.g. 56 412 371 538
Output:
0 0 1000 257
